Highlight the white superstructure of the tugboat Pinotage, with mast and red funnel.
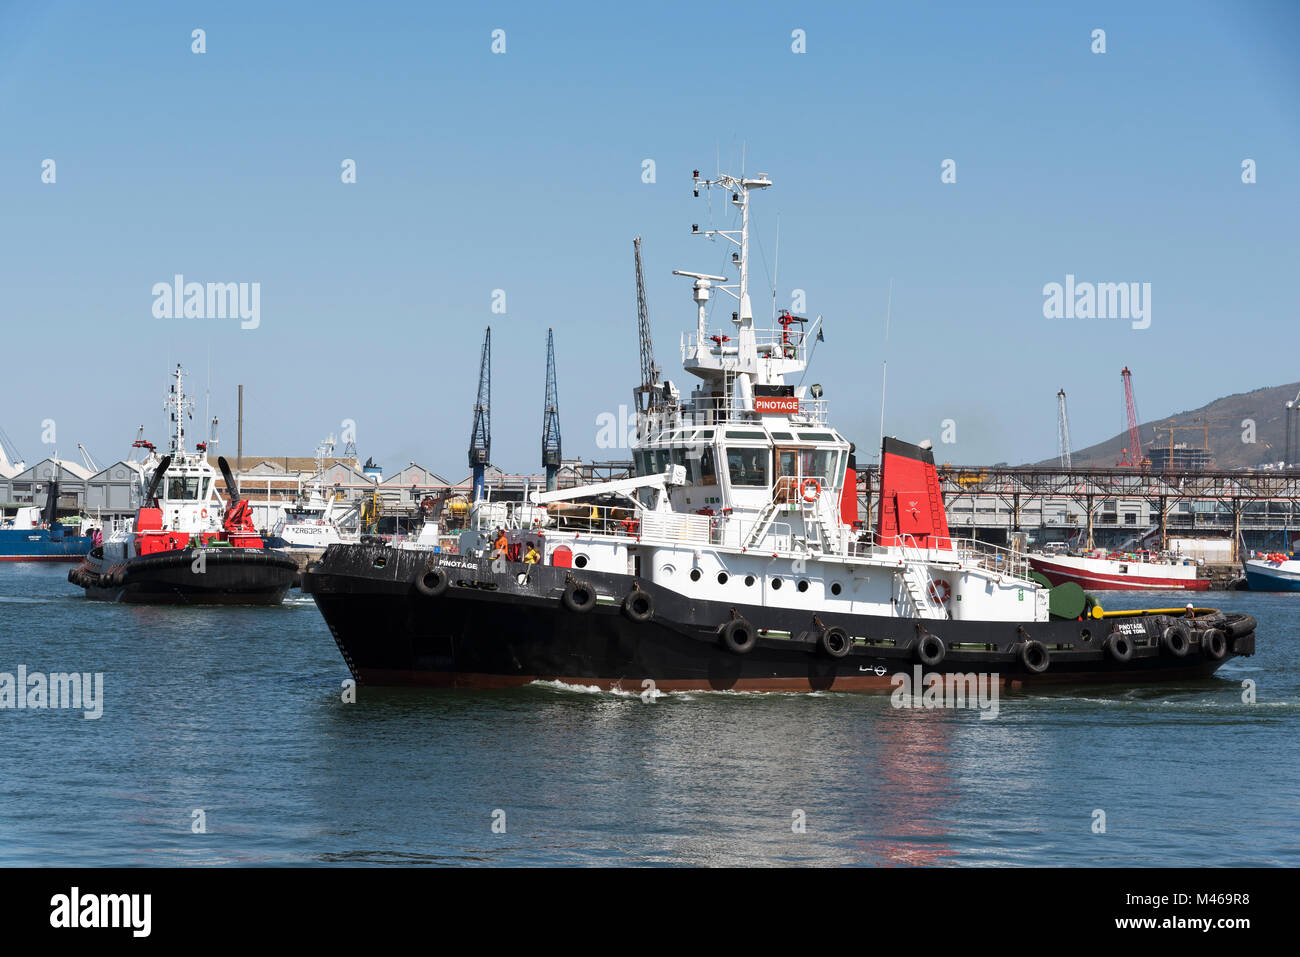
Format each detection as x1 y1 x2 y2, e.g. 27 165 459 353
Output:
511 167 1048 622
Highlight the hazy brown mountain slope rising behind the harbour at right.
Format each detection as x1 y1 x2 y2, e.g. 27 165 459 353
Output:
1035 382 1300 468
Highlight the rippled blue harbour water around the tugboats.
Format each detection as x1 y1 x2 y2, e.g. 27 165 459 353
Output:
0 564 1300 866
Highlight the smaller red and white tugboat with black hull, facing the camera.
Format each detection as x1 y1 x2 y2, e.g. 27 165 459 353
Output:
68 367 298 605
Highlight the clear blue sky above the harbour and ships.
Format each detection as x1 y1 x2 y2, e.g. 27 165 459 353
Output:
0 3 1300 479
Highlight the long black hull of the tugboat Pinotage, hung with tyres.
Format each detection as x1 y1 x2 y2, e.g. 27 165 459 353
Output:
303 545 1255 692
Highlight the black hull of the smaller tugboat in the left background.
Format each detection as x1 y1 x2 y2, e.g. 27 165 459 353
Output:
68 549 298 605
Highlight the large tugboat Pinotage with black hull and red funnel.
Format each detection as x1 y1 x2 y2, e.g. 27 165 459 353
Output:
303 166 1256 692
